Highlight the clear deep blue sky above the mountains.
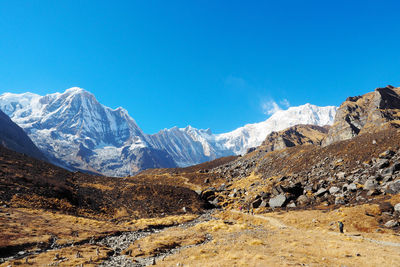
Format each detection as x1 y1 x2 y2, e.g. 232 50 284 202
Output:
0 0 400 133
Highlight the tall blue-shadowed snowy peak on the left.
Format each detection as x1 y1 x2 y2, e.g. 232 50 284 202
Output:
0 87 176 176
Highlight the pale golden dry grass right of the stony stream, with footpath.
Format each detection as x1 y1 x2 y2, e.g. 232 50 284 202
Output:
157 209 400 266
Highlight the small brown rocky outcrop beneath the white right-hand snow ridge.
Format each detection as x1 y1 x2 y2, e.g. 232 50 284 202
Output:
258 125 329 152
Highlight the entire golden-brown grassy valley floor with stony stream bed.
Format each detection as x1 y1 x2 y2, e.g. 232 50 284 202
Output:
0 204 400 266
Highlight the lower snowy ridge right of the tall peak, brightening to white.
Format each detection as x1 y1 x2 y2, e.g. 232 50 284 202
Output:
149 104 337 166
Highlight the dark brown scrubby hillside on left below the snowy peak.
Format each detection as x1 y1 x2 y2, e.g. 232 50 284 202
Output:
0 146 203 219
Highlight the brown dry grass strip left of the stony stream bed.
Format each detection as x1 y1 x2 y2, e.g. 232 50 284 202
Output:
0 208 197 260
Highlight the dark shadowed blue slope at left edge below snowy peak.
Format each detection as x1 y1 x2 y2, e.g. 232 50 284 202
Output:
0 110 47 160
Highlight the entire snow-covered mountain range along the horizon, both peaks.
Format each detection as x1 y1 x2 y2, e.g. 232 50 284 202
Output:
0 87 337 176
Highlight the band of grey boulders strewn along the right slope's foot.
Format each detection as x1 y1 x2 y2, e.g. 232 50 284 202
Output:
211 144 400 211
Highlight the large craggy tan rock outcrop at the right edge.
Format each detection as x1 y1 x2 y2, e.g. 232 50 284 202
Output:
322 85 400 146
